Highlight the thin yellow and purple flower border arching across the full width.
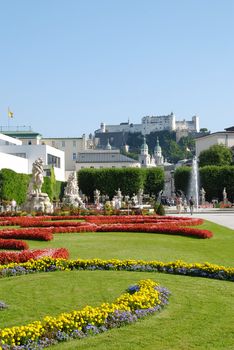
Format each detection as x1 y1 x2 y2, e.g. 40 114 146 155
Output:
0 257 234 281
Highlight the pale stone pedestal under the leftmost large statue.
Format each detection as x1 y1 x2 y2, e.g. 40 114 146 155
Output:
22 193 54 214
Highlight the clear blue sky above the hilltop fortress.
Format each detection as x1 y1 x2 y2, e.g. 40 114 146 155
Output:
0 0 234 137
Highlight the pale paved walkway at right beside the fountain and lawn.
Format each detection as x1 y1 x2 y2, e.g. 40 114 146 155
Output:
167 210 234 230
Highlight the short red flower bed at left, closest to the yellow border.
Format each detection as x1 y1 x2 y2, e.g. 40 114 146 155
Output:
0 248 69 265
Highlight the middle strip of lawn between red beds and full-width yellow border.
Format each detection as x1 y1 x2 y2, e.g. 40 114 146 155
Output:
27 222 234 266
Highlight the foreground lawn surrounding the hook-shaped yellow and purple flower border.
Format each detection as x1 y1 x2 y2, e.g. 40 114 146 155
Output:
0 271 234 350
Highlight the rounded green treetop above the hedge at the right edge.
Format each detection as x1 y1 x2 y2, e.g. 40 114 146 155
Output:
199 144 232 167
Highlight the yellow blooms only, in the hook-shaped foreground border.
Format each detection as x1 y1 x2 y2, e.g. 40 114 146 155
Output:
0 279 160 346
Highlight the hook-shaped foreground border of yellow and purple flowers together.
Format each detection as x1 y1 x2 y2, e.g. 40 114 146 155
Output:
0 279 170 350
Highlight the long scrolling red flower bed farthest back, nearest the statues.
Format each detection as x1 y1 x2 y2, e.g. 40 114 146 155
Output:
0 215 212 240
